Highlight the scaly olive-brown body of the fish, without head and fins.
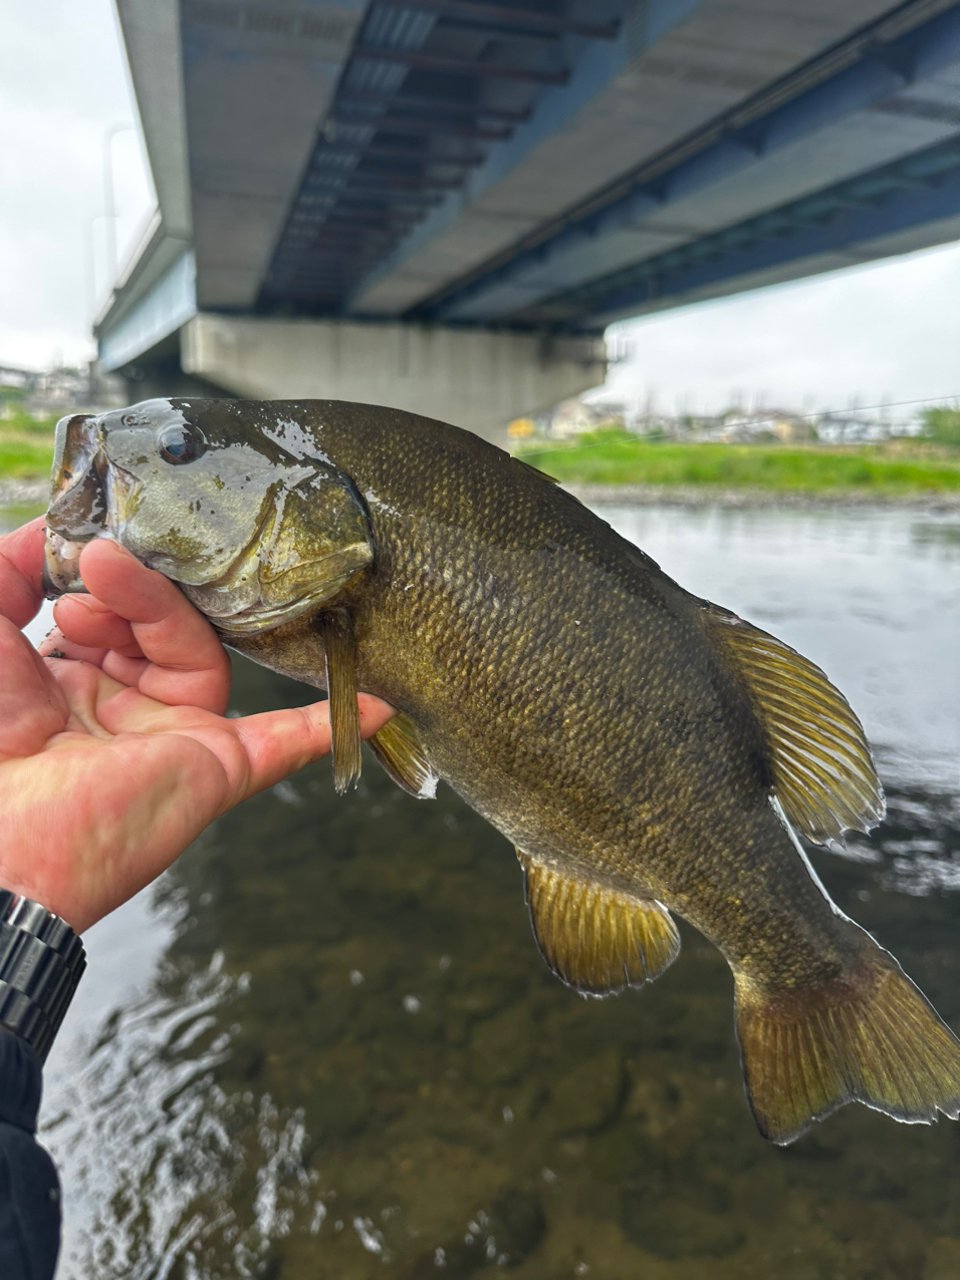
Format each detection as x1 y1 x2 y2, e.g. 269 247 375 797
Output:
225 406 836 982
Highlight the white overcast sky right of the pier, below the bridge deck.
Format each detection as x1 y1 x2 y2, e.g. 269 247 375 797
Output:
603 244 960 412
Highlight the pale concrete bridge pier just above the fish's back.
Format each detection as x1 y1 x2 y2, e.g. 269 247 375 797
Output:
180 312 607 443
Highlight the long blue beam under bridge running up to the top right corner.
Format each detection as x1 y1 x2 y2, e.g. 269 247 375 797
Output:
410 6 960 323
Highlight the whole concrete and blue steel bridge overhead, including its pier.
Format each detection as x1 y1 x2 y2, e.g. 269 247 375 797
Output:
96 0 960 434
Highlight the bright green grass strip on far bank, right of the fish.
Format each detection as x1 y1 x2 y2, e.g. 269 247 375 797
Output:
517 431 960 494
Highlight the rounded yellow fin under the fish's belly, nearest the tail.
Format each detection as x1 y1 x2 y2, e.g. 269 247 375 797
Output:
517 850 680 996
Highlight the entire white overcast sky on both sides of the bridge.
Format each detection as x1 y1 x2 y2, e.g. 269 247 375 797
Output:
0 0 960 412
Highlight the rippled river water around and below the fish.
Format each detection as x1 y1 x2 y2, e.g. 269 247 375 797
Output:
15 508 960 1280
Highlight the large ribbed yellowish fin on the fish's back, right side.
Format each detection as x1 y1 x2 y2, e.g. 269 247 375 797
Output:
703 604 886 845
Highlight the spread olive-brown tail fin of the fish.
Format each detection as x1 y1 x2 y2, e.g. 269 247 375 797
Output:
735 922 960 1146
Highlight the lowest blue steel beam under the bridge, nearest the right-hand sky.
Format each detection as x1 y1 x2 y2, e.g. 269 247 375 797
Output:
535 138 960 333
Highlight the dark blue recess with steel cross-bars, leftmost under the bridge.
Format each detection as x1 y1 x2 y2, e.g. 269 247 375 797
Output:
259 0 632 314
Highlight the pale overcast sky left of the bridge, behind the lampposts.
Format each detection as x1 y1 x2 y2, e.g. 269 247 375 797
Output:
0 0 154 367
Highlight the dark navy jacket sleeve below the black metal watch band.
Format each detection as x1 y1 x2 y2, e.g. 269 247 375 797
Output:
0 1027 60 1280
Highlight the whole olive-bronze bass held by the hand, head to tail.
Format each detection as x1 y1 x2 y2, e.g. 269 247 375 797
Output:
46 399 960 1144
